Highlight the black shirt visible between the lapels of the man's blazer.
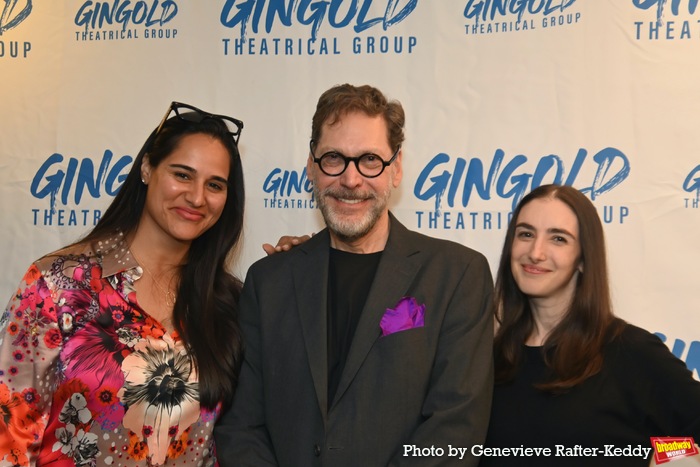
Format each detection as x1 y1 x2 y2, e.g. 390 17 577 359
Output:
327 248 382 408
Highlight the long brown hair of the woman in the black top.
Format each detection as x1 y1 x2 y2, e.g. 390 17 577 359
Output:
494 185 624 393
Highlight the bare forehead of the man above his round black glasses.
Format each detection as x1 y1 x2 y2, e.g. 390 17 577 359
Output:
318 112 389 151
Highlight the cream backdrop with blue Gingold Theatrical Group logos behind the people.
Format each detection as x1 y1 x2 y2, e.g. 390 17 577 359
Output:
0 0 700 377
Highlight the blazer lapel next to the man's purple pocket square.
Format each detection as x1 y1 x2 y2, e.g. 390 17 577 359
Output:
324 215 420 405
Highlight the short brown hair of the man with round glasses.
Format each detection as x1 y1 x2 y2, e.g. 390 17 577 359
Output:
311 84 406 151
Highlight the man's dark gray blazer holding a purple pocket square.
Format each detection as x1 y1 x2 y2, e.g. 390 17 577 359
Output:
215 215 493 467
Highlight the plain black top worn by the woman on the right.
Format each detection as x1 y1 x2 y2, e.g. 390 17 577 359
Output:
480 325 700 466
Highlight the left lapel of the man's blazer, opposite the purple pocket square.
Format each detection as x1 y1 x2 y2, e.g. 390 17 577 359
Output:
293 231 330 421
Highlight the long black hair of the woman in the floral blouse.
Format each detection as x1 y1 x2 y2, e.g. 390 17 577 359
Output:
80 111 245 408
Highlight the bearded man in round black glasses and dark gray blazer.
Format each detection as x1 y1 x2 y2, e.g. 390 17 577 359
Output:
215 84 493 467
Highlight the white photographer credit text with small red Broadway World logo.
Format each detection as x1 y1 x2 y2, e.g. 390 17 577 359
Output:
403 437 700 466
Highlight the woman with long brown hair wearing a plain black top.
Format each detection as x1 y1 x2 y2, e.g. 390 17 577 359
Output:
480 185 700 466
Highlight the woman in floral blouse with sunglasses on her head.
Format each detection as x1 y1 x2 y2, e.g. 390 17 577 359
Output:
0 102 244 466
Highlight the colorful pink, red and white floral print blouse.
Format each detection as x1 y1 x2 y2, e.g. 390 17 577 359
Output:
0 236 220 467
